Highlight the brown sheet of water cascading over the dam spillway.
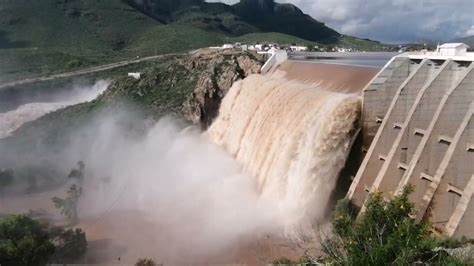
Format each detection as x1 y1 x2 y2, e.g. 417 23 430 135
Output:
207 75 360 233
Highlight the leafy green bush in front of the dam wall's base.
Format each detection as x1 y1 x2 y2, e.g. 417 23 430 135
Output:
323 187 472 265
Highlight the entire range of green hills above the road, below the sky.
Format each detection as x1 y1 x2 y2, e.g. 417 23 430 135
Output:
0 0 386 83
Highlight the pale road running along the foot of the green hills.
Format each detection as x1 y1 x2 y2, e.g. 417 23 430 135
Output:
0 54 183 90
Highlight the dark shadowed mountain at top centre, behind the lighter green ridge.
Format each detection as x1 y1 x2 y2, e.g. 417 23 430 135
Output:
127 0 340 43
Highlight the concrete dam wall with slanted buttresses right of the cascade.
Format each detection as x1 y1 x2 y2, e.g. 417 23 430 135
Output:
347 54 474 237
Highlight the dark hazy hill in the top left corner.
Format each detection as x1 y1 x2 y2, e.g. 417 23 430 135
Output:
0 0 158 54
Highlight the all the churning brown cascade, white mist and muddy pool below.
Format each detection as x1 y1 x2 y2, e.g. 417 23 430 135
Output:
0 69 366 264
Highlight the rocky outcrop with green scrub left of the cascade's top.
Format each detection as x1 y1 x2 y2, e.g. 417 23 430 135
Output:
98 50 264 128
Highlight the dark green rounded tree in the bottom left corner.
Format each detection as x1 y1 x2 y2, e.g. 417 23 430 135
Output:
0 215 55 265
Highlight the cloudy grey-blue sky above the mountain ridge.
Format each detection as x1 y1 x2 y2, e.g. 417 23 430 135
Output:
209 0 474 43
